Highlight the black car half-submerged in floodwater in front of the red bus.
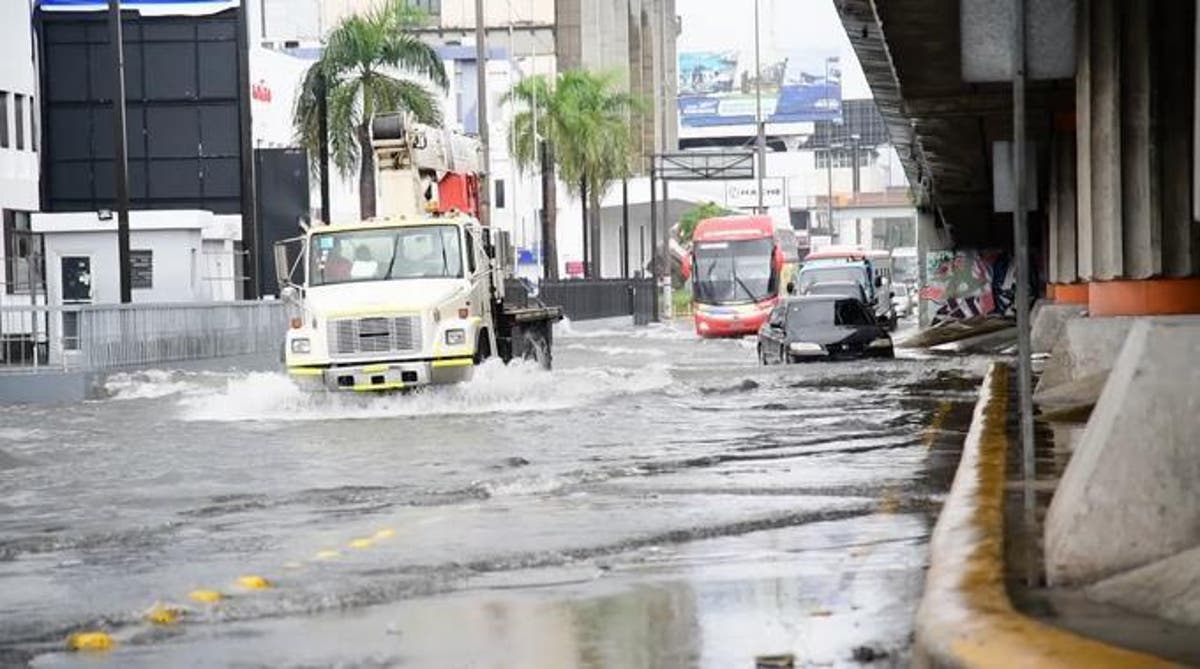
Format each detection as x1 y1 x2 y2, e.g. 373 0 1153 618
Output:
758 295 895 364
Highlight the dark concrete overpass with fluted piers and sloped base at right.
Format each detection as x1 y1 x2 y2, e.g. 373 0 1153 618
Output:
834 0 1200 657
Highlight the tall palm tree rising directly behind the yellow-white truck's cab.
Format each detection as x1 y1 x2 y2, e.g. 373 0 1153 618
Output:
293 0 448 218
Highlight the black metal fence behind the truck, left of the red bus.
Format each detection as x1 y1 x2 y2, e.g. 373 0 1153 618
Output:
538 279 654 325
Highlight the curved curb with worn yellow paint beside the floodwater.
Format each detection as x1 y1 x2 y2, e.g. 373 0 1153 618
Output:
913 362 1175 668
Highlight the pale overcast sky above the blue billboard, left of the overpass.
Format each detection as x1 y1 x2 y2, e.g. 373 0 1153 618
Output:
676 0 871 98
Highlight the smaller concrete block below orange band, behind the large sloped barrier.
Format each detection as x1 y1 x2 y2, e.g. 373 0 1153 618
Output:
1037 318 1136 393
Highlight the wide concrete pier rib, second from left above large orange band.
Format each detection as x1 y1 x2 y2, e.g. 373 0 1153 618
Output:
1088 0 1124 281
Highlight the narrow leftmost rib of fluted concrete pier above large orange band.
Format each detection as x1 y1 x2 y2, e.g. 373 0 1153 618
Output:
1075 0 1092 279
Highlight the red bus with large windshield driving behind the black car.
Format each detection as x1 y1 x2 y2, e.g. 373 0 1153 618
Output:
683 216 800 337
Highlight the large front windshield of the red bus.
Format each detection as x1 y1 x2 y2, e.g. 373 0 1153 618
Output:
692 237 775 305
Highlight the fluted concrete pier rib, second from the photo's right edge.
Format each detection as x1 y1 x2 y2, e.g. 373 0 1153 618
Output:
1118 2 1163 279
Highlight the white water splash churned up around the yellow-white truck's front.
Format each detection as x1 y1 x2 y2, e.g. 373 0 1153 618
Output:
180 361 672 422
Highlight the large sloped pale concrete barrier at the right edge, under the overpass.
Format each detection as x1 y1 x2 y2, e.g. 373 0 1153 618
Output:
1045 317 1200 585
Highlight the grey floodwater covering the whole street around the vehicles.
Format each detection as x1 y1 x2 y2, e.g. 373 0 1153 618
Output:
0 324 986 668
